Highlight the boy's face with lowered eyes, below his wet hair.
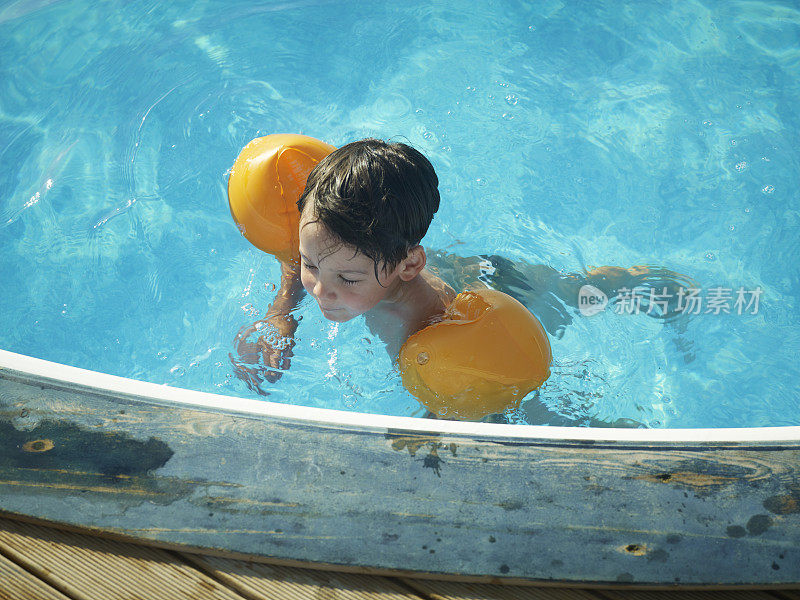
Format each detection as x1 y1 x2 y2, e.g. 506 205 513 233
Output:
300 215 399 323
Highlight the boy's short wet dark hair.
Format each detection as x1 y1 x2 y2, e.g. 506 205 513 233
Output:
297 139 439 278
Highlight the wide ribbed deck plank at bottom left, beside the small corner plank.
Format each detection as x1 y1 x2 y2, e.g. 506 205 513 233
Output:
0 519 247 600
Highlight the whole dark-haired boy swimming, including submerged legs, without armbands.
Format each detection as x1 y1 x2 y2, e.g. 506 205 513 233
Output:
231 139 688 394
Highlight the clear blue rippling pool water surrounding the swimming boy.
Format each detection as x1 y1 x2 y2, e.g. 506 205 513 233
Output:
0 1 800 427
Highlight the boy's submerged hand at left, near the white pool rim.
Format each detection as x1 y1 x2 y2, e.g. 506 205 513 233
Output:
228 313 297 396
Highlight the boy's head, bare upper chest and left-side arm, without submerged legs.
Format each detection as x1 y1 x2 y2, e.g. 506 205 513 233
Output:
235 139 456 393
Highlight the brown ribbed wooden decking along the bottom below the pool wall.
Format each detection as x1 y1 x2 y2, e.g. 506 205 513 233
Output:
0 517 800 600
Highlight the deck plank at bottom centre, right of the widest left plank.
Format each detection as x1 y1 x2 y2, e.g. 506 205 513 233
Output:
181 553 420 600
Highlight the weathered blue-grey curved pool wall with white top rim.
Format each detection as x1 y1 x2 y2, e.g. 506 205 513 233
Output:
0 351 800 586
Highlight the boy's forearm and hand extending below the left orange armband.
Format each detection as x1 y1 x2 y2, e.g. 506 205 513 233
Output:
229 262 305 395
